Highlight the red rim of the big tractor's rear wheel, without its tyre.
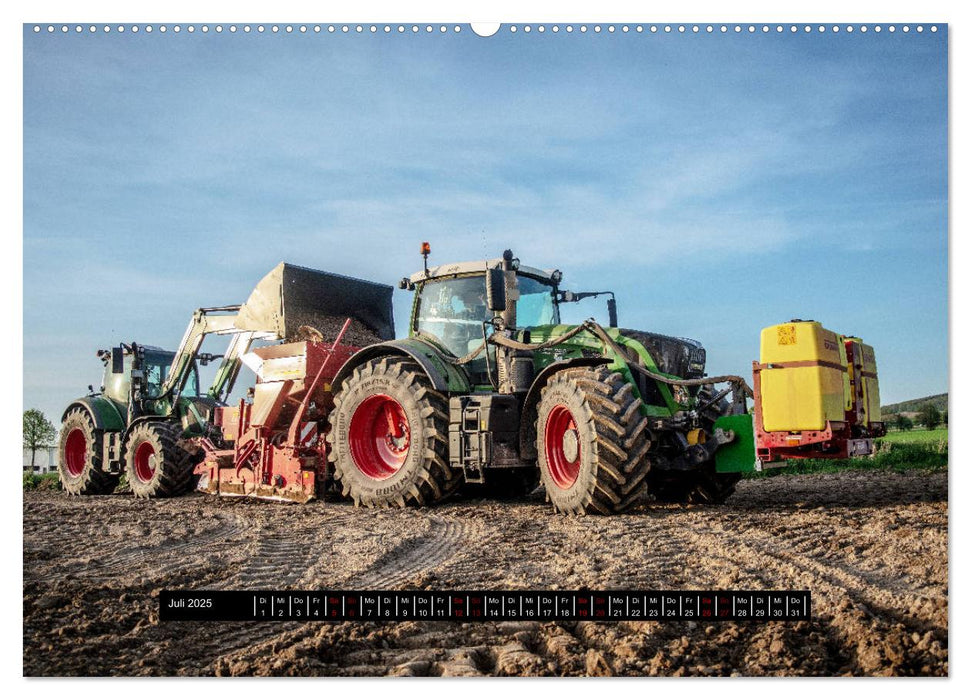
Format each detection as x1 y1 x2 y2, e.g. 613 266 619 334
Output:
348 394 411 481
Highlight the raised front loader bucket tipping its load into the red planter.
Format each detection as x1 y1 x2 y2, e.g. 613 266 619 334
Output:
235 262 394 345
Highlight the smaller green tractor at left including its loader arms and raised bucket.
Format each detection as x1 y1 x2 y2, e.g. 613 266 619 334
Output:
58 263 394 498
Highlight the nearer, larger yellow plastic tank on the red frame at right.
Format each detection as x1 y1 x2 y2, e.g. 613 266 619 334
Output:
759 320 852 432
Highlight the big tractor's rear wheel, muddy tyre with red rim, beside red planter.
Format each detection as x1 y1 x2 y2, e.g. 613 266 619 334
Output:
327 357 462 508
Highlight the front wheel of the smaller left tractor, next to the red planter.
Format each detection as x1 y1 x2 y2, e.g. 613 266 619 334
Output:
125 421 195 498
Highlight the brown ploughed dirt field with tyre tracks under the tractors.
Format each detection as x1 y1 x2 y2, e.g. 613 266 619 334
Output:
24 471 948 676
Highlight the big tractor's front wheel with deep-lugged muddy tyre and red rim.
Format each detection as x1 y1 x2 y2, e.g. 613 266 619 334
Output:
536 366 651 515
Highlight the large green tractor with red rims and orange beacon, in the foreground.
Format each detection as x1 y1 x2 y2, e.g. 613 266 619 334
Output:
327 244 754 514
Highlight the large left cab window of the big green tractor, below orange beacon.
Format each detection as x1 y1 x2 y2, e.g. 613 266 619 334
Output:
415 275 491 357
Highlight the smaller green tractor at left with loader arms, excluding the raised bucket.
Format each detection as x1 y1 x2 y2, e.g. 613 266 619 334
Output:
58 306 254 498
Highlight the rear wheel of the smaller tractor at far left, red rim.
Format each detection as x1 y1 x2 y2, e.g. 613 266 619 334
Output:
57 408 120 496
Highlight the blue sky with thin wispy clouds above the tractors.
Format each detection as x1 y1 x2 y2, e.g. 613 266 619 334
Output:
24 25 948 422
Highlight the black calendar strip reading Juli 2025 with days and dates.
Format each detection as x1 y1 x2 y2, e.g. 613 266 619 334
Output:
159 591 812 622
